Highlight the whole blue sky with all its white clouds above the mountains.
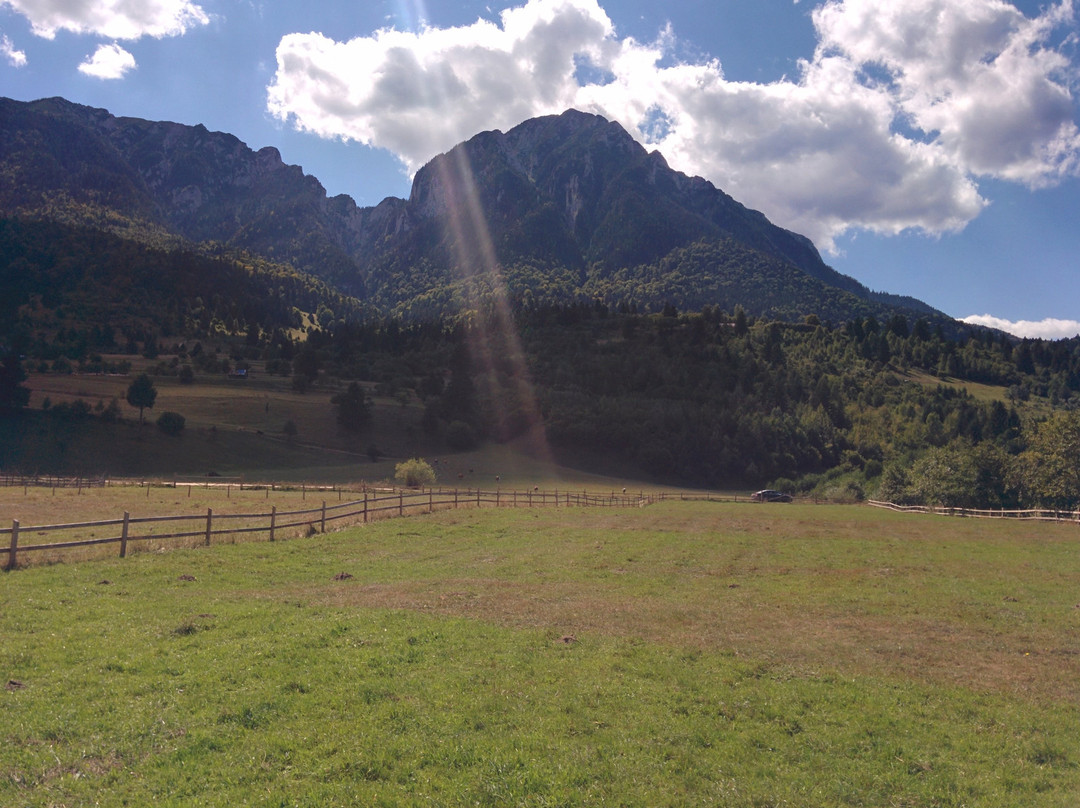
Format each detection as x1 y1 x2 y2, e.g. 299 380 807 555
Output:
0 0 1080 338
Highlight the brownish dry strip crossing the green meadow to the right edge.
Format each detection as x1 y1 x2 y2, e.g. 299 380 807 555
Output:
302 579 1080 704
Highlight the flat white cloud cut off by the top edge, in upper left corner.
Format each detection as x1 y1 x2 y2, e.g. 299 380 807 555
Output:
0 0 210 39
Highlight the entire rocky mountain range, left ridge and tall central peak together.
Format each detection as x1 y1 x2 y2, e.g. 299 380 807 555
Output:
0 98 947 321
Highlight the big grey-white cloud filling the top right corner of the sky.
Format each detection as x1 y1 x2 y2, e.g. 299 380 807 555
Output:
813 0 1080 185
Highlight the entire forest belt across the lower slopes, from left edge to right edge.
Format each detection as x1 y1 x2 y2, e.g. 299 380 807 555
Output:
8 243 1080 508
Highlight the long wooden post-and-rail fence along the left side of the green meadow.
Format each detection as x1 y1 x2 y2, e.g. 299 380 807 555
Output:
0 489 673 569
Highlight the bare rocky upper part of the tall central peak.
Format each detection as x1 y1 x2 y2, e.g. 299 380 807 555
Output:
365 110 867 295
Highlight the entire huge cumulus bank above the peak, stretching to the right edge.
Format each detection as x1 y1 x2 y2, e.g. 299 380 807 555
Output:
268 0 1080 250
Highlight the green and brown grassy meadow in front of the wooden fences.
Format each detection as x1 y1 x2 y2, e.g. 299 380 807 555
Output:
0 503 1080 807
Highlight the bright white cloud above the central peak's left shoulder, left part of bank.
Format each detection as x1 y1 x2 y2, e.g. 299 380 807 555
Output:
269 0 618 171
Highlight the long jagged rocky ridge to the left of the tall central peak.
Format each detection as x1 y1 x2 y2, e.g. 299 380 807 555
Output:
0 98 388 293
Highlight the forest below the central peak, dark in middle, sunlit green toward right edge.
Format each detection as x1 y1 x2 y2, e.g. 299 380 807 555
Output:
223 301 1080 507
